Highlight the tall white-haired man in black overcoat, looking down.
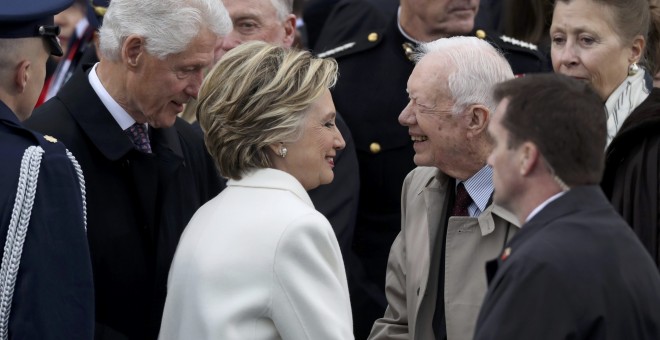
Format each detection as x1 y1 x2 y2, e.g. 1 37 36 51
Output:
27 0 231 339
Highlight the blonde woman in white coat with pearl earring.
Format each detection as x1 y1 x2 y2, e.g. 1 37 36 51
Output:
160 42 353 340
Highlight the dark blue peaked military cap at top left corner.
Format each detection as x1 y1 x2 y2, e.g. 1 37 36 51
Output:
0 0 73 56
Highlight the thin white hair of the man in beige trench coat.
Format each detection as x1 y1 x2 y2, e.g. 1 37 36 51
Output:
415 37 514 114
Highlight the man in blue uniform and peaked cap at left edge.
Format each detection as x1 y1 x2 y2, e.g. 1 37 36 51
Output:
0 0 94 340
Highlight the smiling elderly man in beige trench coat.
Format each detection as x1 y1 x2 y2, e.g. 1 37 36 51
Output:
369 37 518 340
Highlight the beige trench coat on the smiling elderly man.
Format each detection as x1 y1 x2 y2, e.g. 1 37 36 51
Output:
369 167 518 340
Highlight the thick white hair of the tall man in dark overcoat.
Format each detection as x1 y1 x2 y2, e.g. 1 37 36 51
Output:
100 0 232 61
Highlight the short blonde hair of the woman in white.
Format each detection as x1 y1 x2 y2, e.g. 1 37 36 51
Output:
197 41 337 179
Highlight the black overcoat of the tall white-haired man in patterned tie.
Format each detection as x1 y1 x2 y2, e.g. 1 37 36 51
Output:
27 67 221 340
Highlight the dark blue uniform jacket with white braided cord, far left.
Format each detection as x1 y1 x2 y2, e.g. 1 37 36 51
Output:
0 102 94 340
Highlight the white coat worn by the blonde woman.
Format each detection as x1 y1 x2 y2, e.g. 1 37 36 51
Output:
160 169 353 340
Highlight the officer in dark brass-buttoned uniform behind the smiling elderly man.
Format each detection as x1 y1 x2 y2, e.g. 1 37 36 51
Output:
315 0 549 339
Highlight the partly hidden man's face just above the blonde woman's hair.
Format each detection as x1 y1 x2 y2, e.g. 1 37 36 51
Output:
215 0 296 61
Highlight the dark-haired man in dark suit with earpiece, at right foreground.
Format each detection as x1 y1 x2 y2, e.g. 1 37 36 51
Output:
475 75 660 340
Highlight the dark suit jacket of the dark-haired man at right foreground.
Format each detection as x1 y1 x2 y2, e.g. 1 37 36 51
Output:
474 186 660 340
